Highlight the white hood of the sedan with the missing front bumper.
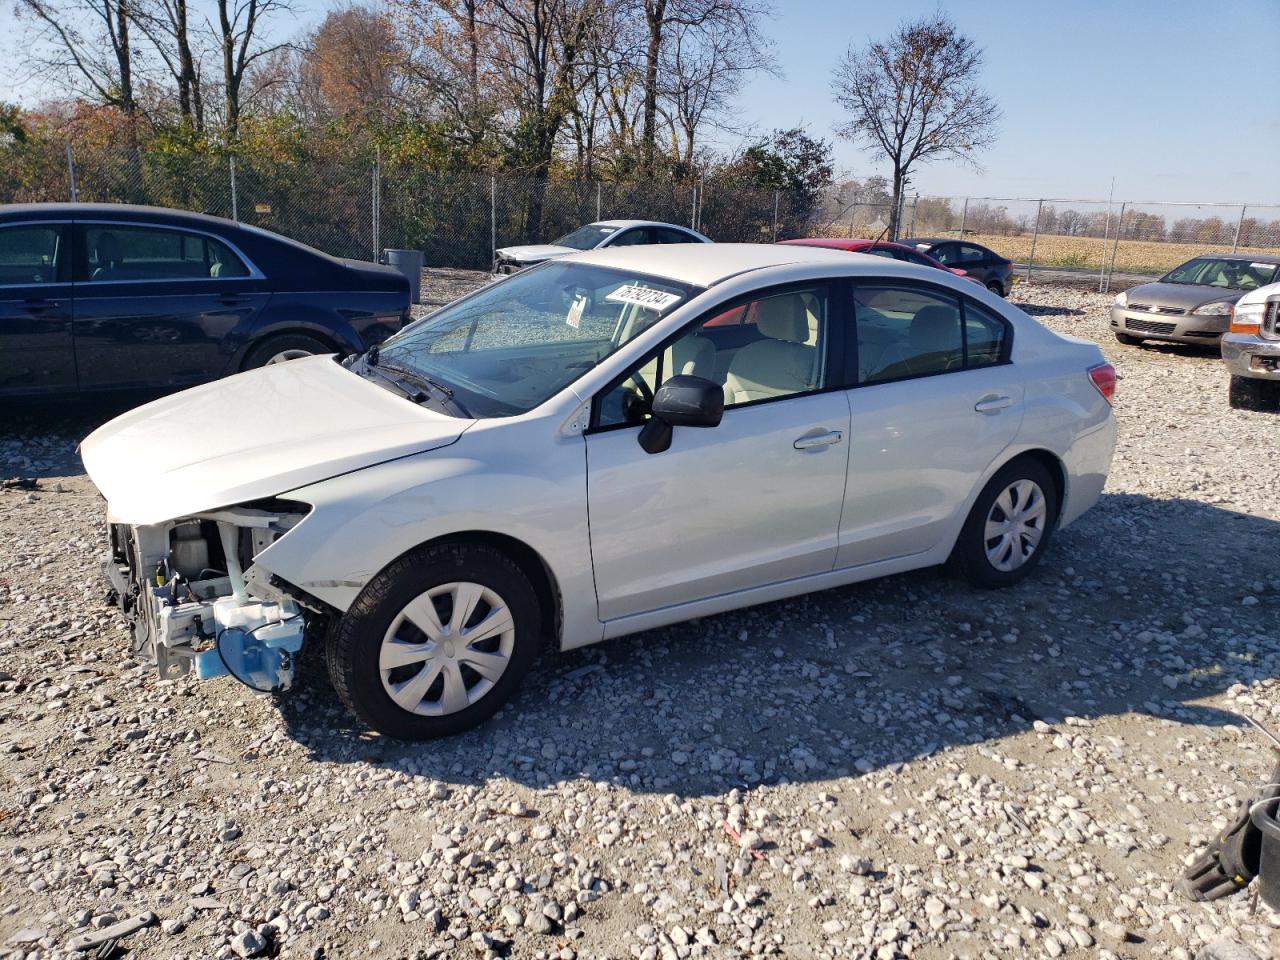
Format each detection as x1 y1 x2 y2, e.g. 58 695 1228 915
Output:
81 357 475 525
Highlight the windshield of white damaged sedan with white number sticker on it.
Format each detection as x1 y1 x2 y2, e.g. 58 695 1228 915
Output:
378 260 700 417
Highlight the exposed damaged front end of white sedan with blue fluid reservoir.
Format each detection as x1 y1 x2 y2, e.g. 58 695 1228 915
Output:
104 499 326 692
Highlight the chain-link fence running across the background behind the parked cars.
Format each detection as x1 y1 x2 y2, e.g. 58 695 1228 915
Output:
0 142 1280 289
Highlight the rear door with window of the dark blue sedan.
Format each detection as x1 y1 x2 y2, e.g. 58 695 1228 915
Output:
74 220 270 390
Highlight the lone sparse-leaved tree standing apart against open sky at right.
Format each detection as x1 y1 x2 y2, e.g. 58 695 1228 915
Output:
832 13 1000 237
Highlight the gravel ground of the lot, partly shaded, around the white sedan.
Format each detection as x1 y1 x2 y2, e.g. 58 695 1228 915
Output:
0 275 1280 960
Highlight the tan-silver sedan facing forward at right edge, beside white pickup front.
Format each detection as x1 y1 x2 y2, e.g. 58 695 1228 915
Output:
1111 253 1280 344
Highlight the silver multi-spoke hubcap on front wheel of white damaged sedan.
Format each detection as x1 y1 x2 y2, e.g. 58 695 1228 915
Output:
378 582 516 717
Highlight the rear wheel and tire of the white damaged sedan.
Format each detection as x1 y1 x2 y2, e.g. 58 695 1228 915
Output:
950 458 1059 588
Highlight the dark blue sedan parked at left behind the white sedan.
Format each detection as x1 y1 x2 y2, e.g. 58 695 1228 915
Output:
0 204 410 397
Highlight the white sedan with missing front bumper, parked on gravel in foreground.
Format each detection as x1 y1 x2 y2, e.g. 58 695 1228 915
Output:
82 244 1115 739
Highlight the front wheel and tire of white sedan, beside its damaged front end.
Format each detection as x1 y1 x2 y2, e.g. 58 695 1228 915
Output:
326 543 541 740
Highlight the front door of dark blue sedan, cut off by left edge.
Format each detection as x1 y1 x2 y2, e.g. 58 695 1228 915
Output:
0 221 76 397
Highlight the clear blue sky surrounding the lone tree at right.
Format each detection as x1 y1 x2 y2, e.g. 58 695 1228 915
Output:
741 0 1280 204
